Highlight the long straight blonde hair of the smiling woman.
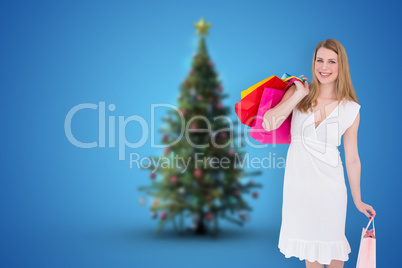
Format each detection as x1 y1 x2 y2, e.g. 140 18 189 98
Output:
296 39 358 112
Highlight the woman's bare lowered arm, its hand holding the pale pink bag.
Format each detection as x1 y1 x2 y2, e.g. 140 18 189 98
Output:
343 112 376 218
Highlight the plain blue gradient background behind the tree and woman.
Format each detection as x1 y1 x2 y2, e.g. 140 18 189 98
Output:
0 1 402 268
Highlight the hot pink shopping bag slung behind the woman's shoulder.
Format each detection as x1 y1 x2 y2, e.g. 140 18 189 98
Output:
249 80 294 144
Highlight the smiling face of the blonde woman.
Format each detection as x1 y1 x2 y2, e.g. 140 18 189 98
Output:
314 47 338 84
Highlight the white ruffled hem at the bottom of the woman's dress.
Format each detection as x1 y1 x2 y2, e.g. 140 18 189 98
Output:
278 239 352 264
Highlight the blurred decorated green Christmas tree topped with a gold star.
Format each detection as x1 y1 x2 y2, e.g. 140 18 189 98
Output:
138 19 261 236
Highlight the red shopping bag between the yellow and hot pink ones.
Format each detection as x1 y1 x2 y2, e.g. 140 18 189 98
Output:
235 76 287 127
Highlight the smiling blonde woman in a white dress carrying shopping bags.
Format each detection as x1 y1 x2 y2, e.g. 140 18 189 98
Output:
263 39 376 268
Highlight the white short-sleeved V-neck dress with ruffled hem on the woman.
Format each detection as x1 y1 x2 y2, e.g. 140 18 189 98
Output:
278 99 360 264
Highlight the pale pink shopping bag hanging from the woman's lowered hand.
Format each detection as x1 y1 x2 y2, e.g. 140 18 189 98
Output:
356 218 376 268
